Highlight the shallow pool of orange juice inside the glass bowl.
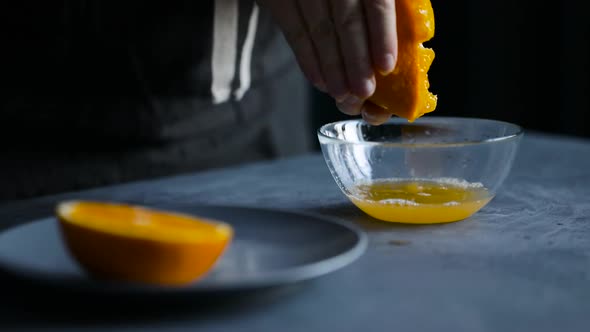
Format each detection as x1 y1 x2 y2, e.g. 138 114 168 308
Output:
349 179 493 224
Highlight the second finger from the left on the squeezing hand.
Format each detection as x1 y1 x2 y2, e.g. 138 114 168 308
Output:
298 0 349 102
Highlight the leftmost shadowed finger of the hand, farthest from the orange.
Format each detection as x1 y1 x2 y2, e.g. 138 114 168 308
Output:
259 0 327 92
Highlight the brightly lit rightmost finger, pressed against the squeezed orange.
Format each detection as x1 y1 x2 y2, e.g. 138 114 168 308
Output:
363 0 398 75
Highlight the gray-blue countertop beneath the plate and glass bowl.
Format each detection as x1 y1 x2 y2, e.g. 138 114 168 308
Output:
0 134 590 332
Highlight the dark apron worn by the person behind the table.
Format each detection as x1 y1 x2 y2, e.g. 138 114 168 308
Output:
0 0 312 201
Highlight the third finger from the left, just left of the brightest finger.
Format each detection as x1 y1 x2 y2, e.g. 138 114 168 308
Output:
331 0 375 99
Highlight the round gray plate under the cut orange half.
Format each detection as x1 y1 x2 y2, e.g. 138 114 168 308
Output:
0 206 367 294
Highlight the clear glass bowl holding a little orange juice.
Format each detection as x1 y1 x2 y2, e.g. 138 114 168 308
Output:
318 116 523 223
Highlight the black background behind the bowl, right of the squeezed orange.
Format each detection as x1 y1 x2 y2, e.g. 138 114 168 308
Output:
313 0 590 147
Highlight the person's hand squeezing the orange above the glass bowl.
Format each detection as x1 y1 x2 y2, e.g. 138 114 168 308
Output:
258 0 397 124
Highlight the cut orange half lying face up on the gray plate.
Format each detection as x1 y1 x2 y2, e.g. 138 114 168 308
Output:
56 201 233 286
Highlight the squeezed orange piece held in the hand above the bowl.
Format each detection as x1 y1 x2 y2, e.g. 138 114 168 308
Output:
369 0 437 122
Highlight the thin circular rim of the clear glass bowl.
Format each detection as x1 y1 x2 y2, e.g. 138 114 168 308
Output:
317 116 524 148
